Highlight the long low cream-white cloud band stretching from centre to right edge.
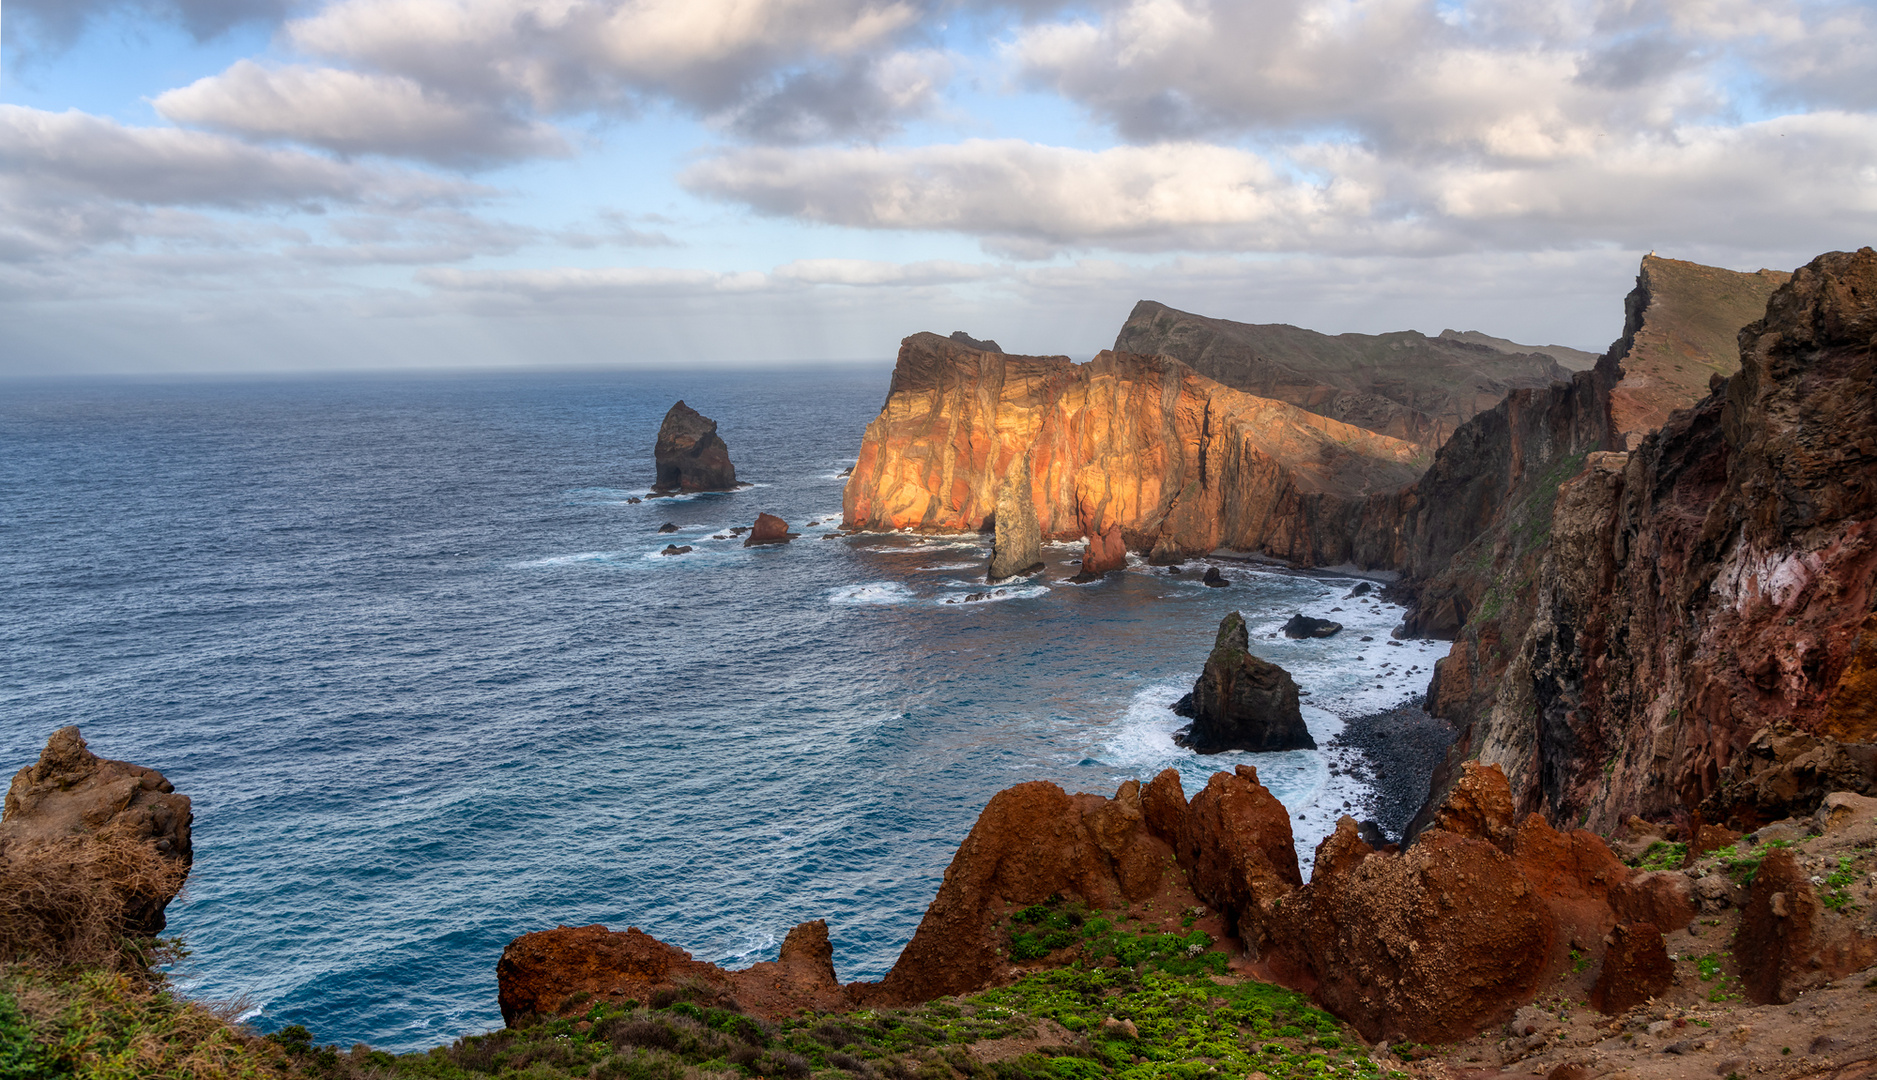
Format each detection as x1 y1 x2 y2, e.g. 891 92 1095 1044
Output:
681 113 1877 259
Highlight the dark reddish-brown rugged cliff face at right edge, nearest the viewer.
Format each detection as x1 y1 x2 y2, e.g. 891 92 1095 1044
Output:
1430 248 1877 828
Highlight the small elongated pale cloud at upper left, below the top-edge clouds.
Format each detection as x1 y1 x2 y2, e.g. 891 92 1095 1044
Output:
154 60 571 165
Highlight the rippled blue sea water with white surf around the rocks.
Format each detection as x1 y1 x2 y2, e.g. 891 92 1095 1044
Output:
0 366 1438 1050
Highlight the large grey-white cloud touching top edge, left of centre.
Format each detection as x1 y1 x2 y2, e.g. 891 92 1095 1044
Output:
287 0 942 141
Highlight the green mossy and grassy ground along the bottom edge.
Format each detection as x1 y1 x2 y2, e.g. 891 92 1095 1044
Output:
0 942 1385 1080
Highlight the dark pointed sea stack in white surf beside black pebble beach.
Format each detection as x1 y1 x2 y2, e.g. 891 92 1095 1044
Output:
1173 612 1316 753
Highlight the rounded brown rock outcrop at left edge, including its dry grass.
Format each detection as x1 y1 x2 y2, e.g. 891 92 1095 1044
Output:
0 727 193 960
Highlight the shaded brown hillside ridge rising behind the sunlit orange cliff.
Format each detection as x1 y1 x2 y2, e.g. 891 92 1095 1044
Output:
1115 301 1571 451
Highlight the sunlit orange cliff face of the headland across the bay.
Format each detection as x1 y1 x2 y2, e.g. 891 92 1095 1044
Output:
843 334 1419 565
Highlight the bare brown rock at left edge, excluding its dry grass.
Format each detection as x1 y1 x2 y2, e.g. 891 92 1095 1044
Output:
0 727 195 935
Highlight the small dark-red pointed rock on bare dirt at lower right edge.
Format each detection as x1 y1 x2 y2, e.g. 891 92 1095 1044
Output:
1734 847 1877 1005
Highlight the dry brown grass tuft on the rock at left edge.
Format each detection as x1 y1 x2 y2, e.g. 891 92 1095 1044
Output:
0 830 188 967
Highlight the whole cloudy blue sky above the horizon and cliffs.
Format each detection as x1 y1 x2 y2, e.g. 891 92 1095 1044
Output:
0 0 1877 376
